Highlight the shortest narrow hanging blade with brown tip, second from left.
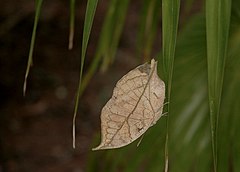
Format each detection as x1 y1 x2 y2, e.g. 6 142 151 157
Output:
68 0 75 50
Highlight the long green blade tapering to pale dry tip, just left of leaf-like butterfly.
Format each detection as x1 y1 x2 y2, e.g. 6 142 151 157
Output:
72 0 98 148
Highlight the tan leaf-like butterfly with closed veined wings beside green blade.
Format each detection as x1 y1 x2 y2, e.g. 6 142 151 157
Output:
93 59 165 150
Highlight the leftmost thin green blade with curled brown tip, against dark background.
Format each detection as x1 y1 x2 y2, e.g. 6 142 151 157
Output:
23 0 43 96
